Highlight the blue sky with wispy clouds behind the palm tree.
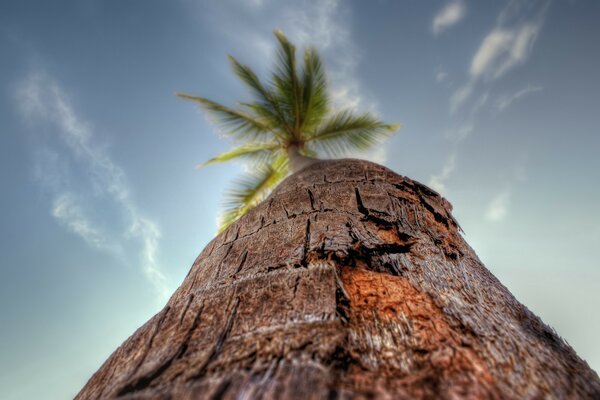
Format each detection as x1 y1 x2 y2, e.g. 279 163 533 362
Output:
0 0 600 399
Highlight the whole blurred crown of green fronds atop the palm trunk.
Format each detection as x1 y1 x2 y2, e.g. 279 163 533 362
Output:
177 31 399 231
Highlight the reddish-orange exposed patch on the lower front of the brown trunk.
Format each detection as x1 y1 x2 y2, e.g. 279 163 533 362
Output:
341 266 499 398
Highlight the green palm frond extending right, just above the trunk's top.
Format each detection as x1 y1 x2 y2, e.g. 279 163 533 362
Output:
306 111 400 156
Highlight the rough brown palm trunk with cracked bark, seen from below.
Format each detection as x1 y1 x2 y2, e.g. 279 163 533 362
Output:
77 160 600 399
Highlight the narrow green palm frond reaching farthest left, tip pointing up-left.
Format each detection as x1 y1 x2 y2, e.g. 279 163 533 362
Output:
177 93 274 139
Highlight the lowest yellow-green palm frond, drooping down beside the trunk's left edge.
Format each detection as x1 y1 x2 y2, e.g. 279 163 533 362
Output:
219 156 288 232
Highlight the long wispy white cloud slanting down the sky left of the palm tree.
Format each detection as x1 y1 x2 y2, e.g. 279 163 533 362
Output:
15 72 169 300
